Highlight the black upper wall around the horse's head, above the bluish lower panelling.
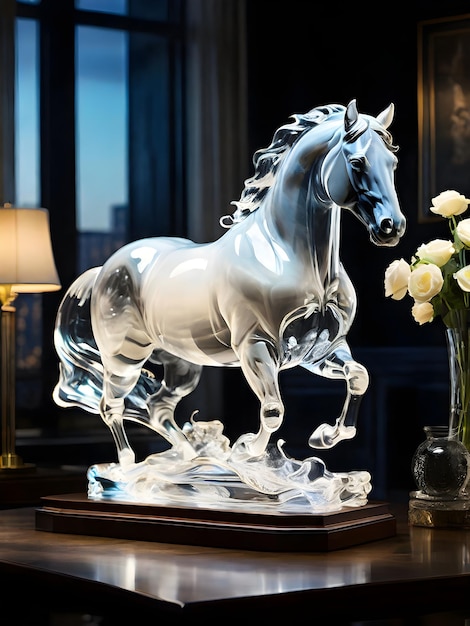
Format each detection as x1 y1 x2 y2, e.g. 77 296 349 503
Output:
247 0 470 346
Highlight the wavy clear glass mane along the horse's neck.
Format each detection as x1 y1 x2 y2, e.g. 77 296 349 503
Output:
220 104 346 228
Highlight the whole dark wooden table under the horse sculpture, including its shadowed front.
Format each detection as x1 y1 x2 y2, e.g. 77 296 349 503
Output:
0 505 470 626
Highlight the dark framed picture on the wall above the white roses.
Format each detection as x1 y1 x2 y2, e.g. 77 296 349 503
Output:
418 14 470 223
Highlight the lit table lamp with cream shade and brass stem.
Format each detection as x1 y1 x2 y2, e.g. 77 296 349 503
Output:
0 204 61 470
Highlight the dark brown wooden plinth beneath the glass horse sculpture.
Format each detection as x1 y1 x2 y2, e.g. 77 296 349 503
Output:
36 494 396 552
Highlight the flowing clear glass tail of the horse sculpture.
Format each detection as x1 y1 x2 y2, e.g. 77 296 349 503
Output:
52 267 103 413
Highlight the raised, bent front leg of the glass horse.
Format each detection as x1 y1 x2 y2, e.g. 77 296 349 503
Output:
302 341 369 449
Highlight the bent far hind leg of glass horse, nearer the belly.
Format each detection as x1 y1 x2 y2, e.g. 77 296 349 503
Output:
147 353 202 460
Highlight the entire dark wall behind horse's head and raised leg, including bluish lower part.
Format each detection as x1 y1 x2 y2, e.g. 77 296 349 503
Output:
232 0 470 497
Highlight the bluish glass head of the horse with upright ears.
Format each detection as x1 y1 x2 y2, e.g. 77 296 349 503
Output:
325 100 406 246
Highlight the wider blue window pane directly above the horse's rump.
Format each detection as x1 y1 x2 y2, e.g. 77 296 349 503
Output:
75 26 129 273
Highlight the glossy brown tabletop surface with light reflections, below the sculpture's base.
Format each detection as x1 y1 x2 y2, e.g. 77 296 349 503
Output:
0 508 470 620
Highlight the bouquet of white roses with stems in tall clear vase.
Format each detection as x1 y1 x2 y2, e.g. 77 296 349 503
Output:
385 186 470 450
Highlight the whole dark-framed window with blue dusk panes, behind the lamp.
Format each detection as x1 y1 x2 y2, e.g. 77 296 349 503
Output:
15 0 185 428
